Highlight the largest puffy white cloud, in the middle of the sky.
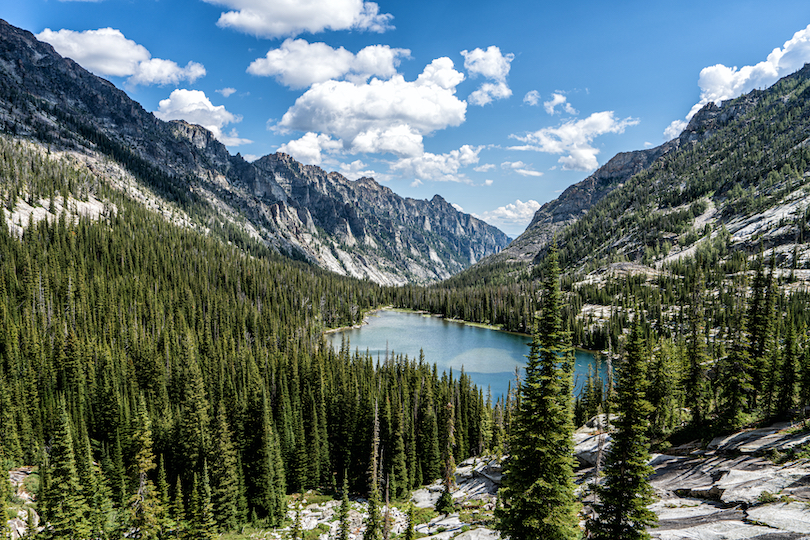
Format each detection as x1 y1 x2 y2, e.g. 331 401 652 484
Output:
275 58 467 157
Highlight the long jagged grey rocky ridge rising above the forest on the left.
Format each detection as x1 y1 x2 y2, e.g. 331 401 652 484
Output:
0 21 509 285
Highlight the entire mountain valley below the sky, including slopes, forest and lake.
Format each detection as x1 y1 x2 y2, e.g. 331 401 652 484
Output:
0 11 810 540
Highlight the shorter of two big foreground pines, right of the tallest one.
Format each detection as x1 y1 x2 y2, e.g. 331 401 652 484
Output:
587 316 657 540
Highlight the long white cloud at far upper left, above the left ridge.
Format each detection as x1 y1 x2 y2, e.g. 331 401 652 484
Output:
37 28 205 85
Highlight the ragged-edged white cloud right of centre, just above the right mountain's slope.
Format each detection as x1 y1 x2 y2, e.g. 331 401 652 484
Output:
509 111 638 171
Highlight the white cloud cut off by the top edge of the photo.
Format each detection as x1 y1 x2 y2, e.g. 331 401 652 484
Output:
204 0 393 38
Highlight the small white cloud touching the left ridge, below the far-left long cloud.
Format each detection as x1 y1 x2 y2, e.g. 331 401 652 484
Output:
153 89 253 146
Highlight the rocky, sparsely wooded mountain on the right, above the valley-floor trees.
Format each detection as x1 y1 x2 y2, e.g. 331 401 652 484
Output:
473 66 810 274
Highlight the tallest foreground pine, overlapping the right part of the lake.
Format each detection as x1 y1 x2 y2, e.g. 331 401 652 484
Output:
496 247 580 540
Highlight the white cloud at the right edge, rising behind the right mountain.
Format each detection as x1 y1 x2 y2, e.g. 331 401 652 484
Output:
664 25 810 139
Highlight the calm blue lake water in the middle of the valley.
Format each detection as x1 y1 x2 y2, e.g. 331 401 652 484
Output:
326 310 607 402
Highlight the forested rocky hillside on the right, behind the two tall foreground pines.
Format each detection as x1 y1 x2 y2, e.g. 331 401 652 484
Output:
390 66 810 448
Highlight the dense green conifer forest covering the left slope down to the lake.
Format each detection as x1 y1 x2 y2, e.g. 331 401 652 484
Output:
0 139 492 538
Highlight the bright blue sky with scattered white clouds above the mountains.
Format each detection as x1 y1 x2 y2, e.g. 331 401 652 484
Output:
0 0 810 237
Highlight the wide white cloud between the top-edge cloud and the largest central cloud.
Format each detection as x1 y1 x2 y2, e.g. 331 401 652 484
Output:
247 39 411 88
